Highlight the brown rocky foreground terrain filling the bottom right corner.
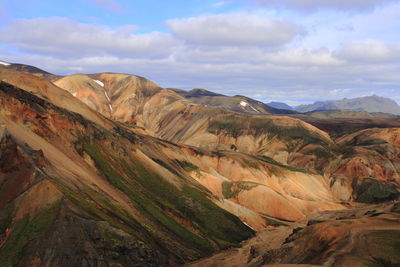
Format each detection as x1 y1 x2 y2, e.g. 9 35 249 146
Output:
189 202 400 267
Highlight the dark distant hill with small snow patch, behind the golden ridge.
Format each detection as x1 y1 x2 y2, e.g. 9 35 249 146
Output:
171 88 296 114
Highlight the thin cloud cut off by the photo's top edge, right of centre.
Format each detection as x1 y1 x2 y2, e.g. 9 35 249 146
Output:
244 0 398 10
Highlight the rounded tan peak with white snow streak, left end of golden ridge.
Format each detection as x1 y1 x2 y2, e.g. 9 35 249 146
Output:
54 73 161 126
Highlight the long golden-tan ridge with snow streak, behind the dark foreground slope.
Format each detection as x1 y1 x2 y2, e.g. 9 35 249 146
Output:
55 73 331 168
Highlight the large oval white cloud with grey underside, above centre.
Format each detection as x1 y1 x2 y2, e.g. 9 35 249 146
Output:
167 13 305 46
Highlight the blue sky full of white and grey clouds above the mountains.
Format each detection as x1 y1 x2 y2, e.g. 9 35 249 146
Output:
0 0 400 105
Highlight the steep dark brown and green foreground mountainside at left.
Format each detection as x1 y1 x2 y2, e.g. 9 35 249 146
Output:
0 76 253 266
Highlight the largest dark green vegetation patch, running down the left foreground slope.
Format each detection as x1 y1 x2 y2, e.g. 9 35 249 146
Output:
84 143 253 254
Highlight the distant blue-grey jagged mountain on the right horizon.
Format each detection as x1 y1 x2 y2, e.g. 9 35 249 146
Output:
295 95 400 115
